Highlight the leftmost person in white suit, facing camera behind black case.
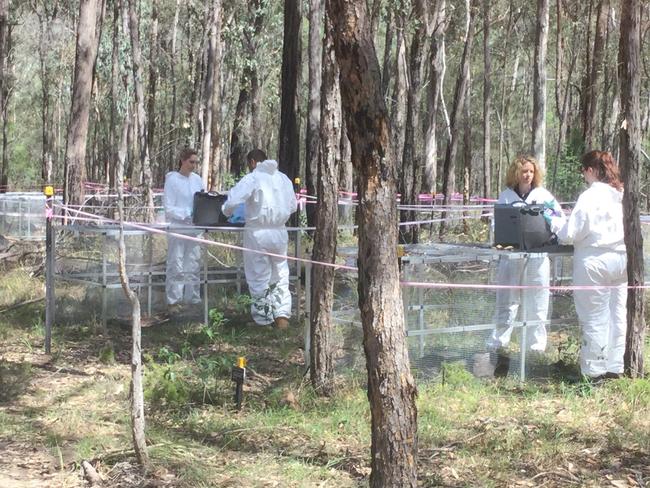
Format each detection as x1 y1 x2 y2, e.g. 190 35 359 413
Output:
163 148 204 306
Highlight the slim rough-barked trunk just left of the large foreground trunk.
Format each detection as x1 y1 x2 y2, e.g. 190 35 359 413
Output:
310 9 341 395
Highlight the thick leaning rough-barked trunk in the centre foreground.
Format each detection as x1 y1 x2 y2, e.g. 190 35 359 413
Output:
326 0 417 488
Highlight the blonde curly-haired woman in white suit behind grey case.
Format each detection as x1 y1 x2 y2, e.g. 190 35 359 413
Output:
488 156 564 376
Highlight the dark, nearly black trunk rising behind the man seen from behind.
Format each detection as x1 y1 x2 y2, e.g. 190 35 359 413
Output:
278 0 301 181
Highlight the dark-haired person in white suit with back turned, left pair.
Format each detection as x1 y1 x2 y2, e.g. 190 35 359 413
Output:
222 149 297 329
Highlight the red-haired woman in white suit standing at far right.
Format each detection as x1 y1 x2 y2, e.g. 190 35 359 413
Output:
551 151 627 380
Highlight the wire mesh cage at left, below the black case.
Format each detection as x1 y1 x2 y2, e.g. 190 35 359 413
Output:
55 225 300 324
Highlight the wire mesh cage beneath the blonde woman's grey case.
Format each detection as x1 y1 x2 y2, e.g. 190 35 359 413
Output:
333 244 579 380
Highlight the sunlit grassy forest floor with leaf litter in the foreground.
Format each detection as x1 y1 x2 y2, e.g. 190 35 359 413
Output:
0 270 650 488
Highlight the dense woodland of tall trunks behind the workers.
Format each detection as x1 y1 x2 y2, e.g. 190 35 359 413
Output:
0 0 650 207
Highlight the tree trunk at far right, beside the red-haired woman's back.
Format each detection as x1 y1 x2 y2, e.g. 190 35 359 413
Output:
618 0 645 378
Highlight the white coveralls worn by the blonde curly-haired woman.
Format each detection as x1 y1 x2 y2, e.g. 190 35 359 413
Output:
488 187 563 351
